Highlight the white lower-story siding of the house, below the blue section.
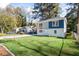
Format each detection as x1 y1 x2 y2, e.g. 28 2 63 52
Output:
37 28 65 37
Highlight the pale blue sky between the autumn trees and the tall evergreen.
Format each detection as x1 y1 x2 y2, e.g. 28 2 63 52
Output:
9 3 34 22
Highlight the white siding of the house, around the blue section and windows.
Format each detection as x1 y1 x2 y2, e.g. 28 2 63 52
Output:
37 18 67 37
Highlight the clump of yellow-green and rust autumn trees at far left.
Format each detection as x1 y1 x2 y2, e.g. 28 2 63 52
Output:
0 6 26 33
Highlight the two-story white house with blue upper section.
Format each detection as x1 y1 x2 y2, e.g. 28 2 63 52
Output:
37 17 67 37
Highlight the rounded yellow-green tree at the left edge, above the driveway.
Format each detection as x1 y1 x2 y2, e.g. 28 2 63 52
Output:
0 13 16 33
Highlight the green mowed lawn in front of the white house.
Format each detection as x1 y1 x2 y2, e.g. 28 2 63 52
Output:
0 36 79 56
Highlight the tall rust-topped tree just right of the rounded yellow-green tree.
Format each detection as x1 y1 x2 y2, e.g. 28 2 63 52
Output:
15 7 26 27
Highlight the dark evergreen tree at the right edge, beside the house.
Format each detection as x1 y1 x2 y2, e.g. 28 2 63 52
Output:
66 3 79 39
